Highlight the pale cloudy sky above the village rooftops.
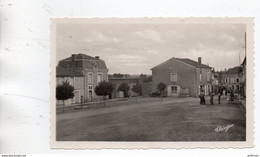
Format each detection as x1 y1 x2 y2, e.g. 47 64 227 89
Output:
56 23 246 74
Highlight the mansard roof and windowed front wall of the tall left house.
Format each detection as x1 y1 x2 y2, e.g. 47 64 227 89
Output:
58 53 108 101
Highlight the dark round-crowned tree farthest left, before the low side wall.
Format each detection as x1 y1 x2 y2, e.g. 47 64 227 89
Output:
56 81 74 112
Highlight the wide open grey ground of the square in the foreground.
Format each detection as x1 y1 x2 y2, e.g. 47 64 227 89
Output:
56 97 246 141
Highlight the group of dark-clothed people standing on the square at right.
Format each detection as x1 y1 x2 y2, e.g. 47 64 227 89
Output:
199 90 235 105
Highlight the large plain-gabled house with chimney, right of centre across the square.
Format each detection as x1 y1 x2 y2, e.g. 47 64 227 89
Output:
151 57 213 96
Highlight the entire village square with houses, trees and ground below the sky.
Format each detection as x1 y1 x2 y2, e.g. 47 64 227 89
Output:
56 53 246 141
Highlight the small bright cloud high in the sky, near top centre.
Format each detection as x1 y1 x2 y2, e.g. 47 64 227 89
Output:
133 29 162 42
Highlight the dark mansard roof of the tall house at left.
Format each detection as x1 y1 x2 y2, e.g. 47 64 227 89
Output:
58 53 107 69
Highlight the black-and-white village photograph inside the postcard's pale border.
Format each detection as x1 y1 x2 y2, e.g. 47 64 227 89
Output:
52 19 254 148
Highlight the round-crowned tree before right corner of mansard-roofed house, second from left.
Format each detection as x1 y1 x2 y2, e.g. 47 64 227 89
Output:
95 81 113 107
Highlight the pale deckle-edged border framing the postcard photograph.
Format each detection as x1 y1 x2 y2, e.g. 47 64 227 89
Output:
50 17 254 149
